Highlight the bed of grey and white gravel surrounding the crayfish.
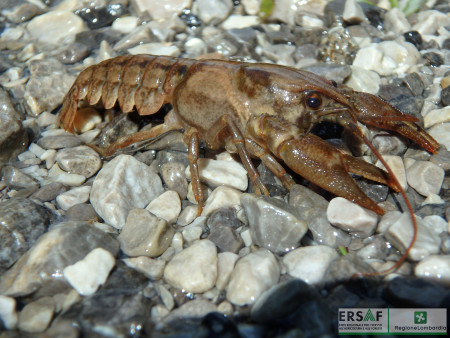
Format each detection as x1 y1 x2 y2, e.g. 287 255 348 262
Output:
0 0 450 337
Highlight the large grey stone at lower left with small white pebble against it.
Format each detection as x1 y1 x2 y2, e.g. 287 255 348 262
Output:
0 222 119 297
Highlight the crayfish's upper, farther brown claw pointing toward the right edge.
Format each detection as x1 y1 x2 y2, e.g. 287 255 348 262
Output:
351 92 439 154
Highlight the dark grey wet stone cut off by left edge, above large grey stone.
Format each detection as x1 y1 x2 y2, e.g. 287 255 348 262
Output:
0 198 52 271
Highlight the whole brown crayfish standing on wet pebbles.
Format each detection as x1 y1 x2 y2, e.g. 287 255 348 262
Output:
60 55 439 276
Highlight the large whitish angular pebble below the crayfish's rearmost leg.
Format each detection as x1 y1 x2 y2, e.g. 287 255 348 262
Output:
91 155 164 229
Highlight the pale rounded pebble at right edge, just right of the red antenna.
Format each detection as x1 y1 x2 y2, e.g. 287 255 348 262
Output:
406 161 445 196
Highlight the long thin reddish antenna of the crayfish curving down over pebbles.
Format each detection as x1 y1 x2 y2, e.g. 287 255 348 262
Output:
350 131 417 278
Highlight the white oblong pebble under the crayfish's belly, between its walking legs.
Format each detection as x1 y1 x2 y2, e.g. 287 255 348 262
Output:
186 158 248 191
